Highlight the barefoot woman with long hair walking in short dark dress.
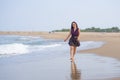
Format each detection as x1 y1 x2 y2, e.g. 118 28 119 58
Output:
64 22 80 61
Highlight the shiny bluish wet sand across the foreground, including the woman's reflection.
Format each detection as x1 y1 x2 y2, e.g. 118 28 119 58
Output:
0 53 120 80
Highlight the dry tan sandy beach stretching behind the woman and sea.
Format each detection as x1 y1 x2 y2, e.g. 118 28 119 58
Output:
0 32 120 80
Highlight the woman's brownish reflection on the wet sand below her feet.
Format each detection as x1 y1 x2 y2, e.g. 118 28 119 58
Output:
71 61 81 80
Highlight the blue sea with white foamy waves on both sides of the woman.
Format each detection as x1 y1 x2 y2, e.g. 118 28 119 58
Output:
0 35 105 57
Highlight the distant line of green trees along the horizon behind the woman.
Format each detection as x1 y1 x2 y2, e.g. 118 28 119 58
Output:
52 27 120 32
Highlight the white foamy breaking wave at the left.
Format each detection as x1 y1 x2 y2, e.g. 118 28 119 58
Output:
0 43 61 55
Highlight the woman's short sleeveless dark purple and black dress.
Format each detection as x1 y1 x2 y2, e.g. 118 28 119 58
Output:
68 29 80 47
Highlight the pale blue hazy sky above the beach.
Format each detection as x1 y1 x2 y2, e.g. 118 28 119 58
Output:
0 0 120 31
